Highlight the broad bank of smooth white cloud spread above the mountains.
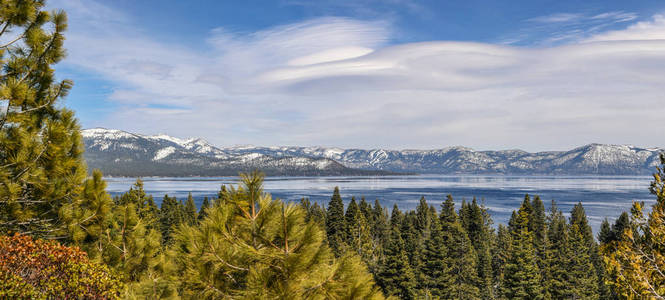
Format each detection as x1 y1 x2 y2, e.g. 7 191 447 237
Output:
49 4 665 150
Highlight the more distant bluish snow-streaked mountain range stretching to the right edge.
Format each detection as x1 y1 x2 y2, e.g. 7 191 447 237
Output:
226 144 665 175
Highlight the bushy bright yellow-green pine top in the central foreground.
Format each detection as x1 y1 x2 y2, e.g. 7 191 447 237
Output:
173 173 383 299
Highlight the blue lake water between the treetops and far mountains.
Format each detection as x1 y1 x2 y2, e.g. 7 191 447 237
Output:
106 175 655 232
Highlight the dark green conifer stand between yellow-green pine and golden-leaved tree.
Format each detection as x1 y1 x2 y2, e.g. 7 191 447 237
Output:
302 189 600 299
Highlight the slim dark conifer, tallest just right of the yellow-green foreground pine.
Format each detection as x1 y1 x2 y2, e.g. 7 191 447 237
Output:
326 187 347 257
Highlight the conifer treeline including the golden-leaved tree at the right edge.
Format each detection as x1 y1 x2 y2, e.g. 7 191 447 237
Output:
301 158 665 299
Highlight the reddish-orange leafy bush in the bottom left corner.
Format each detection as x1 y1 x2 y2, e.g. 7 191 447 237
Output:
0 234 122 299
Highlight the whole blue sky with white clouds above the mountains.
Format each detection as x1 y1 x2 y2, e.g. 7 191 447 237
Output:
48 0 665 151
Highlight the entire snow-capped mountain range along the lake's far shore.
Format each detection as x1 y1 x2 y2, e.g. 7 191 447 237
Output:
83 128 664 176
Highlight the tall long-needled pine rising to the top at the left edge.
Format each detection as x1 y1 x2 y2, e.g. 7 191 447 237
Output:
0 0 80 238
